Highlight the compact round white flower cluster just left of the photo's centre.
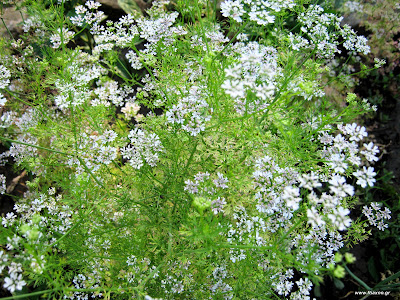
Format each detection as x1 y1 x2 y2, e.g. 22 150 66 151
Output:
121 128 164 169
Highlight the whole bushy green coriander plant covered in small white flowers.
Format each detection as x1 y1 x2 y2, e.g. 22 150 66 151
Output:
0 0 390 299
